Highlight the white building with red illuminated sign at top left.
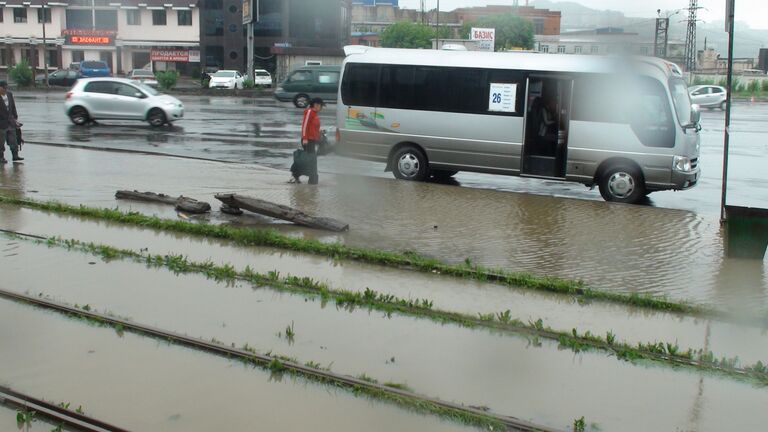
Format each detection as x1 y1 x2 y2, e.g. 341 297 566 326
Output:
0 0 200 73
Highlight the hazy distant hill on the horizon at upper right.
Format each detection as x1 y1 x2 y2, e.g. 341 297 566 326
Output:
532 0 768 58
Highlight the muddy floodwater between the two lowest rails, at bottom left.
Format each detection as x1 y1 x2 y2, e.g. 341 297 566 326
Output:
0 300 476 431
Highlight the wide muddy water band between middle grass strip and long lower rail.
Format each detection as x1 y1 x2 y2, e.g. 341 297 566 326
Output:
0 241 768 431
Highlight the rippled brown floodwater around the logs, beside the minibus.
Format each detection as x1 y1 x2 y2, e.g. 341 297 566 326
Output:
0 146 768 313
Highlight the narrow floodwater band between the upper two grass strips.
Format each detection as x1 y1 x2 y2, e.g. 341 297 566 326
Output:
0 205 768 364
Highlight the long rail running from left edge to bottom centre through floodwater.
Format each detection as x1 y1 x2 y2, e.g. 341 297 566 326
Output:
0 289 558 432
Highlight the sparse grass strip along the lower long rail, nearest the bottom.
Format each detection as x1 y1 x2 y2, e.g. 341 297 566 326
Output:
1 293 516 431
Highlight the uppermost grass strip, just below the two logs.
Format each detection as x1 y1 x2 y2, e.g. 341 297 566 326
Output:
0 195 712 317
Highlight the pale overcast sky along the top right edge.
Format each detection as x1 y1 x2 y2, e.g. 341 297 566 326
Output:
400 0 768 29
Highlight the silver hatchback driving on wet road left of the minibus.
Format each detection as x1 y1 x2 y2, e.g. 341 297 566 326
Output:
64 78 184 127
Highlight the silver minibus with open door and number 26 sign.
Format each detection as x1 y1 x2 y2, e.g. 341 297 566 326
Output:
337 46 700 203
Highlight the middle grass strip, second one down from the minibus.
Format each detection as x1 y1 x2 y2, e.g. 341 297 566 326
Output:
31 238 768 385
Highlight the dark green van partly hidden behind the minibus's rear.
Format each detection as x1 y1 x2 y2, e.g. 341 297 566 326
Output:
275 66 341 108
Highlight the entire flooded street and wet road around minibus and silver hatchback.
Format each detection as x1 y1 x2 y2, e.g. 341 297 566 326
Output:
0 92 768 432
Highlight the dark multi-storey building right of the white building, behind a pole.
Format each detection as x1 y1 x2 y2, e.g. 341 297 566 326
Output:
200 0 351 80
